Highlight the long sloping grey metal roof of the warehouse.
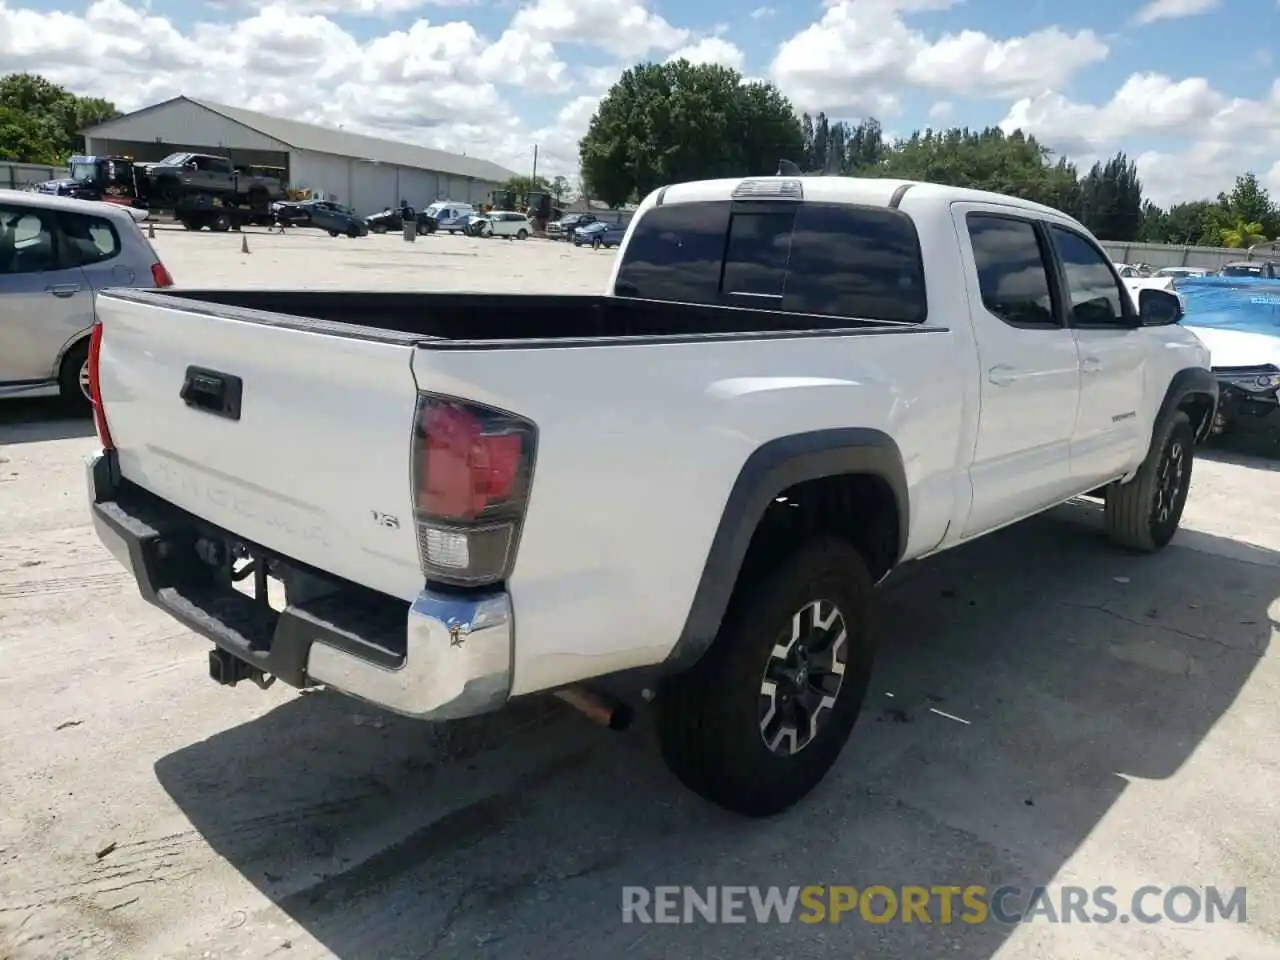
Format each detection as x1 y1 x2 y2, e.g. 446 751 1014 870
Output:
90 96 518 183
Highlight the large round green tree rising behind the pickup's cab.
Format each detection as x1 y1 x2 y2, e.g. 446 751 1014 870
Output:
579 60 804 206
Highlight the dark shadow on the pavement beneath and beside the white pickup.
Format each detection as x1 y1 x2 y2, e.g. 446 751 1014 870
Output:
155 504 1280 960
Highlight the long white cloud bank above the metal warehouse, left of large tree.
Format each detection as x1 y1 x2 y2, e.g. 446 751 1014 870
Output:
0 0 577 173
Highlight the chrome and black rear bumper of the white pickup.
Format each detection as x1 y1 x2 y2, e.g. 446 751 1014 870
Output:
87 453 513 719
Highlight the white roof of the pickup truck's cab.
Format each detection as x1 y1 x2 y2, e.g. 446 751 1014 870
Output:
662 177 1065 216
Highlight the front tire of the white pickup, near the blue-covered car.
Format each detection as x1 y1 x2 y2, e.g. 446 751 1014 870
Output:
1105 410 1196 553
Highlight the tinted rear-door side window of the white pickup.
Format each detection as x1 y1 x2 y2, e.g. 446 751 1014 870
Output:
965 214 1060 330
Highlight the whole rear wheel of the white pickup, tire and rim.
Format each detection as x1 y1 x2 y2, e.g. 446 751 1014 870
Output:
658 538 874 817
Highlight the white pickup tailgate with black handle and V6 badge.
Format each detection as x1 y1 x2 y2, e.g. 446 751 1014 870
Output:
96 292 422 600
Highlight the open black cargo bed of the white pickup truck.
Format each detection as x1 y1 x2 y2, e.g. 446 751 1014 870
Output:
99 289 919 348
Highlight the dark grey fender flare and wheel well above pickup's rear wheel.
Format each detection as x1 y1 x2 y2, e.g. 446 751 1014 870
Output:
664 428 910 672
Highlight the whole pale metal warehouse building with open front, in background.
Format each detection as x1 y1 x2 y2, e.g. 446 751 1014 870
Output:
81 96 517 215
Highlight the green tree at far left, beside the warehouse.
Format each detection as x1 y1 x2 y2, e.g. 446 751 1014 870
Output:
0 73 120 164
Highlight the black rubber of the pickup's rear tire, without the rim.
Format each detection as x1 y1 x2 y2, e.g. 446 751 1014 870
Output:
658 538 874 817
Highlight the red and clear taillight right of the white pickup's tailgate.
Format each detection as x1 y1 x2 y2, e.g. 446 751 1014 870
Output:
413 394 538 586
